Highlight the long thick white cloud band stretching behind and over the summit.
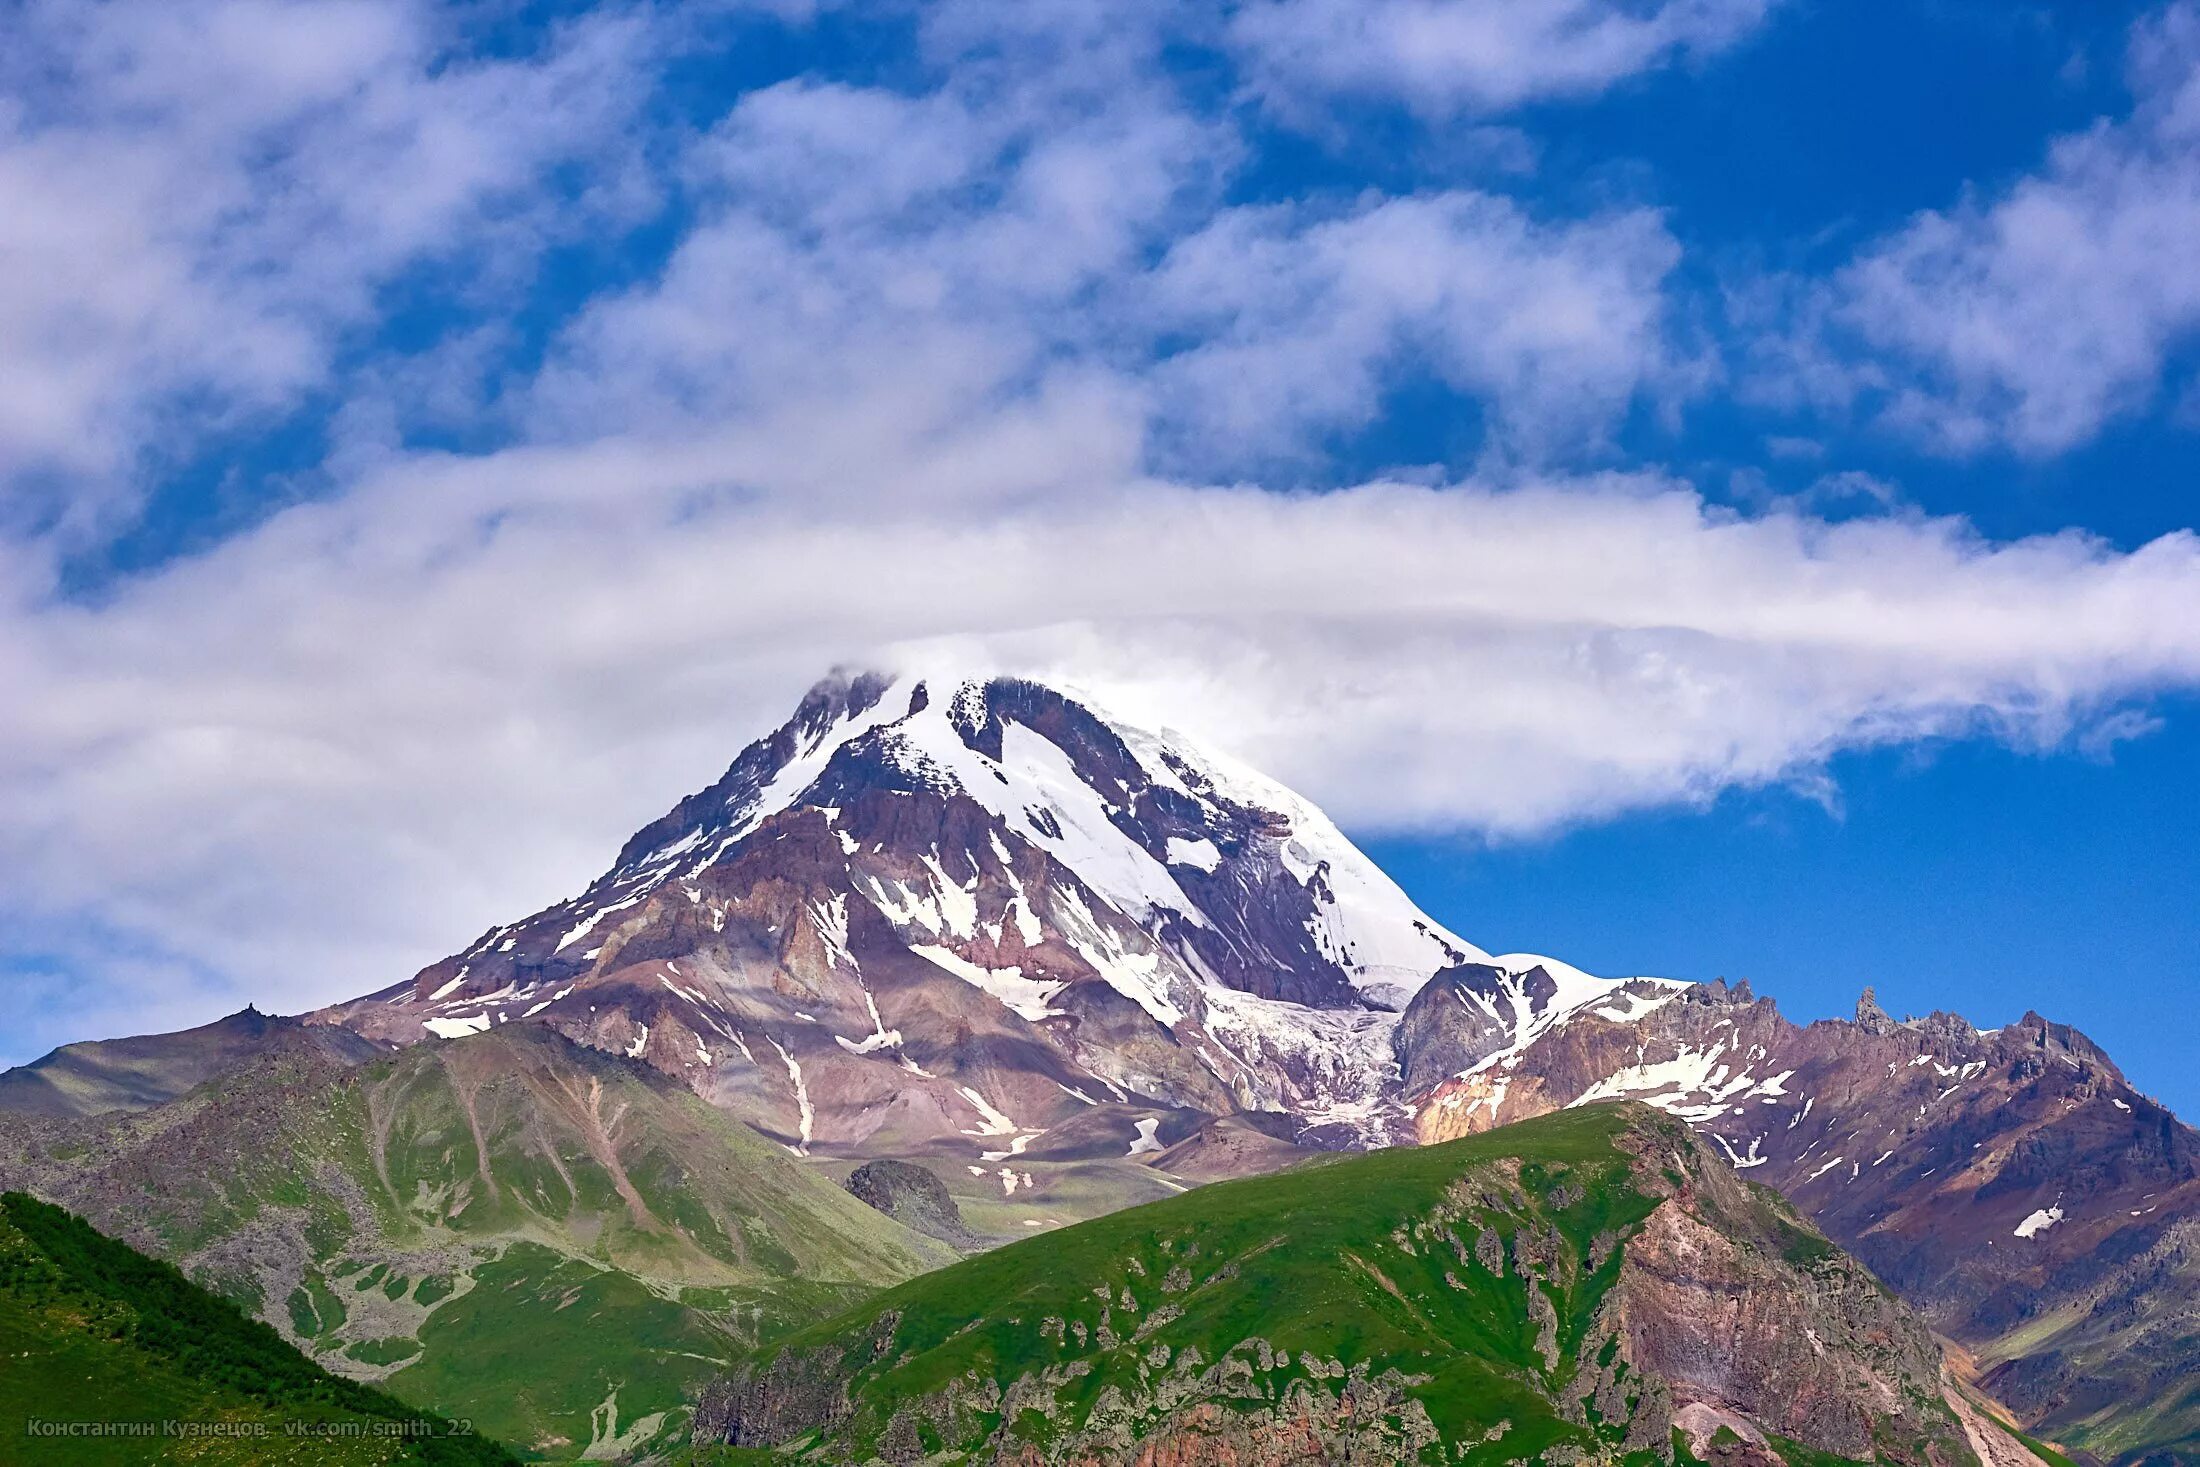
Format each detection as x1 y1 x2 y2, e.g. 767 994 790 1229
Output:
0 439 2200 1055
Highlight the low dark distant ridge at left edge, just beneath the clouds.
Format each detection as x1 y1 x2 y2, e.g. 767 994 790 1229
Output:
0 1005 387 1115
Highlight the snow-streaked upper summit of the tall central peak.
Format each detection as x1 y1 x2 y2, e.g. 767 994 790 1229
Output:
607 669 1485 1010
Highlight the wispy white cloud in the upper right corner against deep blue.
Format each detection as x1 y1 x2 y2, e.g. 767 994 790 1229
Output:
1771 4 2200 455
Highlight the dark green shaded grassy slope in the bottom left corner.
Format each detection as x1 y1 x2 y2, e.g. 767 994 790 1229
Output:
0 1192 513 1467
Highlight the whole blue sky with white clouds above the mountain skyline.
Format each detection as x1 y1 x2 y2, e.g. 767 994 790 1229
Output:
0 0 2200 1115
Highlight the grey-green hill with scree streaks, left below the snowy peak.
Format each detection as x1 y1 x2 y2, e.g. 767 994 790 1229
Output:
0 1025 955 1456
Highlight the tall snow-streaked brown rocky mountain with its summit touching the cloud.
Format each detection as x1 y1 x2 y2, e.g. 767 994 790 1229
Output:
317 675 1636 1161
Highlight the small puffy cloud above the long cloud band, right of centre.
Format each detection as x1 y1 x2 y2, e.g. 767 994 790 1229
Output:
1153 191 1692 462
